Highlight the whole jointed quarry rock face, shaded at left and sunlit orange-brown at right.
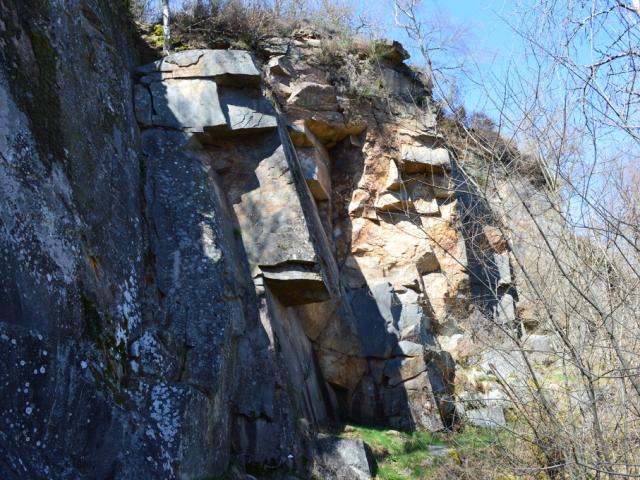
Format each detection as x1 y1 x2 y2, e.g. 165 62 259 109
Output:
0 0 528 479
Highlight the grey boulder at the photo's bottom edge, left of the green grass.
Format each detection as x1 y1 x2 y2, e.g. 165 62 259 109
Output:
309 435 374 480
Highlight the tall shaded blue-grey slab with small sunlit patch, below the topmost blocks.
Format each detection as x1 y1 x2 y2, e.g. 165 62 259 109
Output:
142 129 244 386
